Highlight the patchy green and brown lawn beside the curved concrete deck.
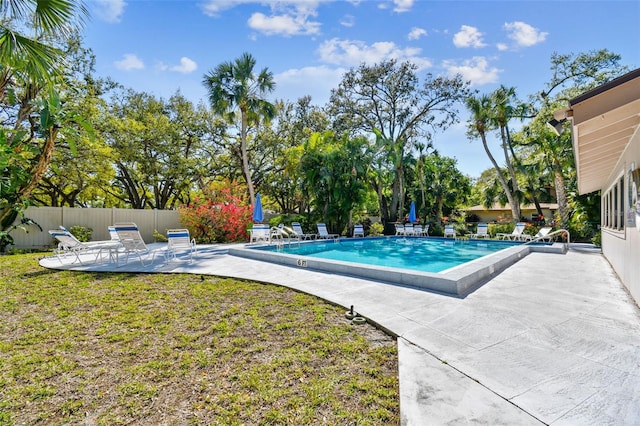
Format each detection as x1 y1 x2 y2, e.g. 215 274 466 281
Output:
0 254 400 425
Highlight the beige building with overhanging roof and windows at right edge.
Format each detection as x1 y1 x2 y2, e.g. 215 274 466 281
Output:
554 69 640 302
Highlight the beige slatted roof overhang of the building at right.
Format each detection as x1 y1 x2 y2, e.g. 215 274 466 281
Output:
554 69 640 194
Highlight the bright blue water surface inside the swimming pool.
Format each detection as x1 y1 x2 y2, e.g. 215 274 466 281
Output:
253 238 518 272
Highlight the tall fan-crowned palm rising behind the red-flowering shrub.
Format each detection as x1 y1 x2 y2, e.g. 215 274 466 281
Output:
203 53 276 205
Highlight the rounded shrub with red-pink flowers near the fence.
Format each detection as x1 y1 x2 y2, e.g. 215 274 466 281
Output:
179 182 252 244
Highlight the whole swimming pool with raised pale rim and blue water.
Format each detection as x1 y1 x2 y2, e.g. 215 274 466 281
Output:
229 236 566 297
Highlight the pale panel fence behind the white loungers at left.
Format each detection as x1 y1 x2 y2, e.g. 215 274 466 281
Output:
9 207 183 249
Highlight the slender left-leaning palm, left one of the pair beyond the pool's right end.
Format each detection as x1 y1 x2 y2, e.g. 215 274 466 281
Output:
465 95 520 221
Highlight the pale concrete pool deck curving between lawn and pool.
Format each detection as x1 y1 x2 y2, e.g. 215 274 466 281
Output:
40 241 640 426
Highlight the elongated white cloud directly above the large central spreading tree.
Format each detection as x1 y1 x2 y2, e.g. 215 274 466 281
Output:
318 38 432 69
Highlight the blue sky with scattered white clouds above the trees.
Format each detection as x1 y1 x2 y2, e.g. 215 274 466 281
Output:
84 0 640 177
